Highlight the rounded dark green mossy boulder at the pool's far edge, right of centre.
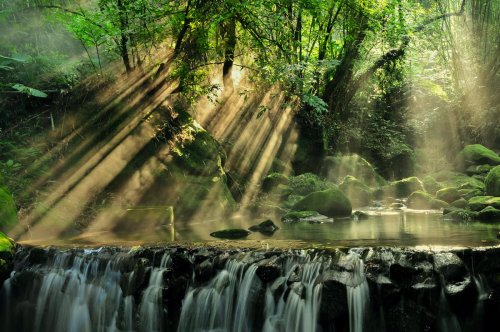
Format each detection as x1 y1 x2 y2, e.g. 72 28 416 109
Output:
293 188 352 218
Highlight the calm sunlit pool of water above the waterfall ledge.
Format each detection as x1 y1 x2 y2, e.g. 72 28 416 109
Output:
17 210 500 247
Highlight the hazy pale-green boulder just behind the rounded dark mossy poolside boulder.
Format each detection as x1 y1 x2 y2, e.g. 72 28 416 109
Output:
321 154 387 187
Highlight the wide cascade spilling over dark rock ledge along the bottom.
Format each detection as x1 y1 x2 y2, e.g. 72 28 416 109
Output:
0 248 500 332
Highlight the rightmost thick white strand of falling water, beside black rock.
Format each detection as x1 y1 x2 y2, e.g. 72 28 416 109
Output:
346 249 369 332
